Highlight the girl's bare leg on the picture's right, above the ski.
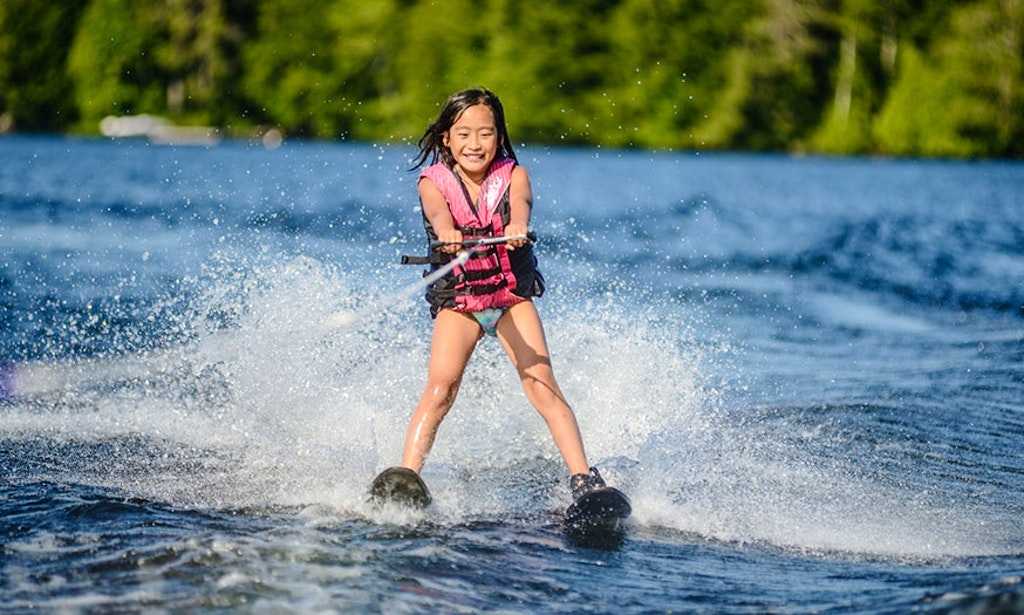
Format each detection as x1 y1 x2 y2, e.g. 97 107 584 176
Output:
498 301 589 474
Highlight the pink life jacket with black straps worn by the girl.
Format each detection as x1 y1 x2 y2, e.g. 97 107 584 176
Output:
420 158 526 312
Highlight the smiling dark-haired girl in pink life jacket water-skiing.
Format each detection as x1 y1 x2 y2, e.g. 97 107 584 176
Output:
387 88 604 499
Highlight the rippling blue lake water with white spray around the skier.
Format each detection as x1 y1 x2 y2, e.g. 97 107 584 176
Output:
0 137 1024 613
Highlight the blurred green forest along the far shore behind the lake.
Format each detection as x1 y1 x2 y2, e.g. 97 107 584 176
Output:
0 0 1024 158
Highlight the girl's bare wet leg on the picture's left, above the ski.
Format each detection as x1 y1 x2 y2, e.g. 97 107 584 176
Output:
401 310 480 472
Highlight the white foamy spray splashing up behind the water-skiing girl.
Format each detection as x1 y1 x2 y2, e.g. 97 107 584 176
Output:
0 246 1020 560
